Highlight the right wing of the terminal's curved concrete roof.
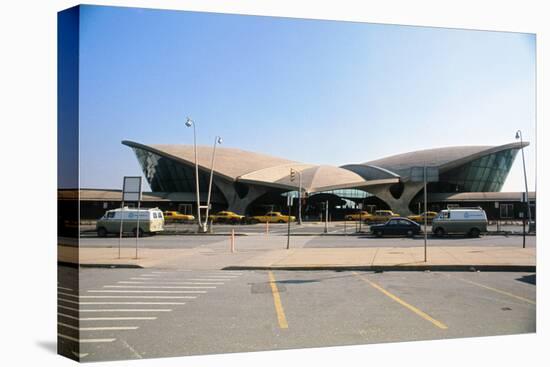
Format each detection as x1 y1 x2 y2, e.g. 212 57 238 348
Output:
363 142 529 176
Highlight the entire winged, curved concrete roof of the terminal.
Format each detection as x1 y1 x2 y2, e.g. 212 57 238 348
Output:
122 140 529 193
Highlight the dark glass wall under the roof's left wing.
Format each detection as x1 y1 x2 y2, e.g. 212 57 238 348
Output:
133 148 220 194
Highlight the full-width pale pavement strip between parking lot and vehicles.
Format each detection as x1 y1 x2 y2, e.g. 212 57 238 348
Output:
58 241 536 271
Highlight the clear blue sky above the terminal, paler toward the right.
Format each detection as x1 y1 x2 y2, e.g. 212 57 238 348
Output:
75 6 536 191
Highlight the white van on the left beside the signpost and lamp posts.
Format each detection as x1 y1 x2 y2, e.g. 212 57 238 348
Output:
96 207 164 237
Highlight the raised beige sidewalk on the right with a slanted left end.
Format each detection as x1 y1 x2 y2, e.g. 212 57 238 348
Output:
226 247 536 271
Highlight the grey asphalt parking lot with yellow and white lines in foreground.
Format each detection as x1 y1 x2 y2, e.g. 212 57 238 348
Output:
58 267 535 361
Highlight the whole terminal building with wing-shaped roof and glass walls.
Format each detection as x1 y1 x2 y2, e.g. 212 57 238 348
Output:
105 141 534 219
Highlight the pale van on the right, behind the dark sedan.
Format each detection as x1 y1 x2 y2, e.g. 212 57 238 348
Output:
432 208 487 237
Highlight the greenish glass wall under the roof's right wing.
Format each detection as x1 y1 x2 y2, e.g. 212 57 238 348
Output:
438 149 518 192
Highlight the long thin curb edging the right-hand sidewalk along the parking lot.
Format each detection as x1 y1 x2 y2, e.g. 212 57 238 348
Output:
222 265 537 273
